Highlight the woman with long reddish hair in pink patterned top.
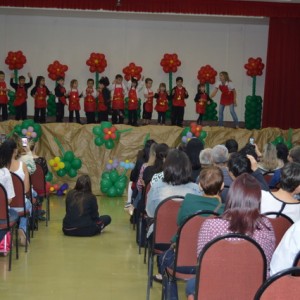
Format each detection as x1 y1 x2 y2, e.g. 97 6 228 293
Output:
186 174 275 300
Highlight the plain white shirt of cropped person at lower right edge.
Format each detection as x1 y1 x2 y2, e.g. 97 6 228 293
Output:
270 221 300 275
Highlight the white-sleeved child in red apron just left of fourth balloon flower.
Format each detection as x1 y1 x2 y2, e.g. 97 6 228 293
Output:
109 74 127 124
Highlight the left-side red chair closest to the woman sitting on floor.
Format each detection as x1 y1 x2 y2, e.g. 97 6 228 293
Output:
30 162 50 226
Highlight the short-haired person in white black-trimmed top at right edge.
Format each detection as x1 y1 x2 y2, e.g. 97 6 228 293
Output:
260 162 300 222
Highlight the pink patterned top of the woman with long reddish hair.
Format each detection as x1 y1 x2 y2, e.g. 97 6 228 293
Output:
197 218 275 274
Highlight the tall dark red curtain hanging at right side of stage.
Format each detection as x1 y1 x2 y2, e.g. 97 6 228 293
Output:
258 18 300 129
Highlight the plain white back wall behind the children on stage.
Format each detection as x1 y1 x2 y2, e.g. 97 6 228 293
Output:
0 11 268 120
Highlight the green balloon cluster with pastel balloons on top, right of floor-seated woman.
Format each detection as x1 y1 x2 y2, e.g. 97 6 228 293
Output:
100 159 134 197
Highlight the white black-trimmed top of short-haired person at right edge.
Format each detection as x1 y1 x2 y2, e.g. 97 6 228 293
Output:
260 191 300 222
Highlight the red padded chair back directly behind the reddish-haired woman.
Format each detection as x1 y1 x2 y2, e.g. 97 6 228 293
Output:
195 234 267 300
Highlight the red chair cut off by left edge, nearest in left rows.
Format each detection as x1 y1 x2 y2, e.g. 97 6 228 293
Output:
0 184 19 271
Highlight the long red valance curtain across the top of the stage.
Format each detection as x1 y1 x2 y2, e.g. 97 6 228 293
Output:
0 0 300 17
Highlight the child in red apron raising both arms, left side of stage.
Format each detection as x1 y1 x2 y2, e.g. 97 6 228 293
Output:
10 73 33 121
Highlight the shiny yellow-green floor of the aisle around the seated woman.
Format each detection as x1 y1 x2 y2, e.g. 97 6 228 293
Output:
0 196 185 300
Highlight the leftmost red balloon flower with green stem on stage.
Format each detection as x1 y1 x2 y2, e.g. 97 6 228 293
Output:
5 50 27 116
